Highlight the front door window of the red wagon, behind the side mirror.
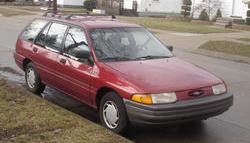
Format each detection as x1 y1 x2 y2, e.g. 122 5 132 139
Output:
64 27 89 57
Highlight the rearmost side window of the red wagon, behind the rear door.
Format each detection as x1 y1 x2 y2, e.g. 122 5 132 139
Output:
21 20 48 42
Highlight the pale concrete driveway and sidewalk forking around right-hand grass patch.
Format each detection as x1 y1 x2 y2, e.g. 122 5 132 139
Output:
155 29 250 64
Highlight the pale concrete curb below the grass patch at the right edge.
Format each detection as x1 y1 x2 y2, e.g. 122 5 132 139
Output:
192 49 250 64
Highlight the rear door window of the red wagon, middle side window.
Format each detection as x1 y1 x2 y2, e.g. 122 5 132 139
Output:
45 23 67 51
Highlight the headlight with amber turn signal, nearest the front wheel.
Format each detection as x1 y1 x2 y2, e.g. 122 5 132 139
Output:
132 93 177 105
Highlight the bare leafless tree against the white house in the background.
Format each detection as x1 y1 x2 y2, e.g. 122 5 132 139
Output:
193 0 222 19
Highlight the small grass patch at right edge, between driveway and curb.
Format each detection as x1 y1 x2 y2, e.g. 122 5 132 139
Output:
199 41 250 57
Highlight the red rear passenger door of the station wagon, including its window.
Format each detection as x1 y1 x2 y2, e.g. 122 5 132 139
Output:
32 22 68 89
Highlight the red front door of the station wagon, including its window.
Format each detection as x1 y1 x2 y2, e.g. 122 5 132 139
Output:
58 27 92 104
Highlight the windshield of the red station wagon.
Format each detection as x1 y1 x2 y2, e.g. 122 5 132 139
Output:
91 27 173 61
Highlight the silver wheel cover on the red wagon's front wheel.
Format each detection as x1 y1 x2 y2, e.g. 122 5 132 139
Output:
102 101 119 129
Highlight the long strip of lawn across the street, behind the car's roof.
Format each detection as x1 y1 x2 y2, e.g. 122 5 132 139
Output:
118 16 236 34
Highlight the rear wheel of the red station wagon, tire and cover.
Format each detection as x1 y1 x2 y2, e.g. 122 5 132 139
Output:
25 62 45 95
